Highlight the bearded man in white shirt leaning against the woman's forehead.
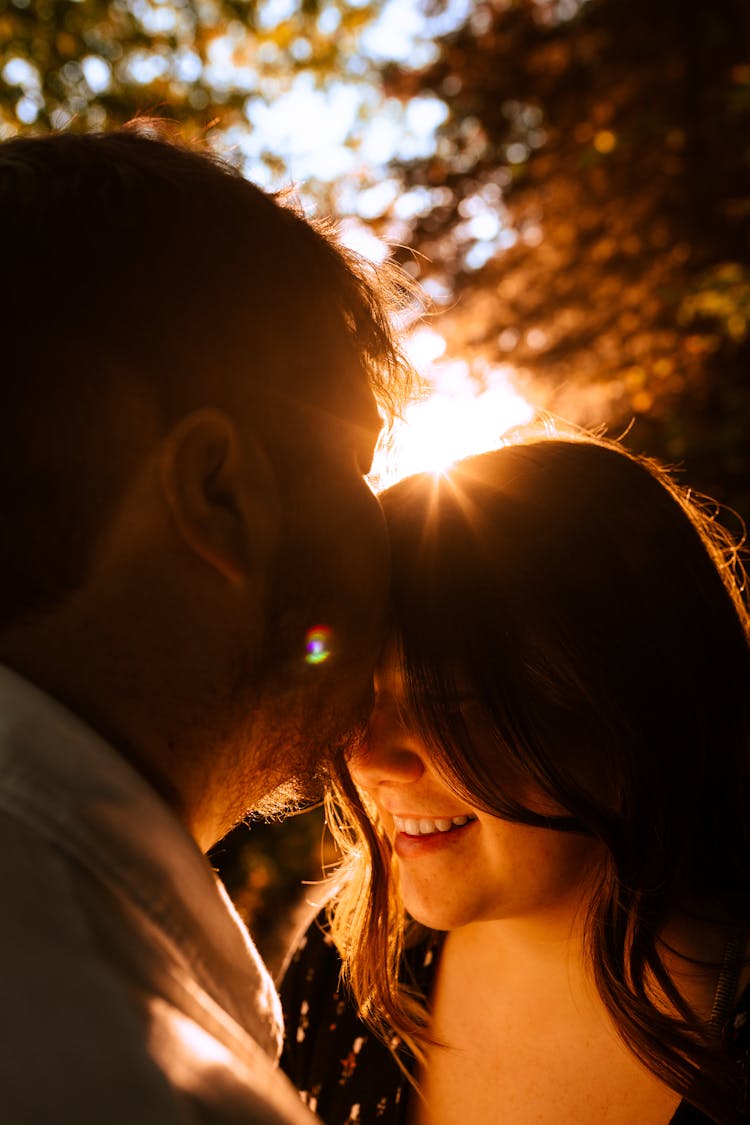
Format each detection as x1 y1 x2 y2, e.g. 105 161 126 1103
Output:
0 127 408 1125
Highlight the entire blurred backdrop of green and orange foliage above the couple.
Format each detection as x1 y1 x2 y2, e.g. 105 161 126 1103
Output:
5 0 750 508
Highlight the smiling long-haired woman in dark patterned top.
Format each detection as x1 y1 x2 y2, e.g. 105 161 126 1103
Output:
282 438 750 1125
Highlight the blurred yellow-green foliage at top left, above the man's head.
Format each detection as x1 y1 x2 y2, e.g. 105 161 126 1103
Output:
0 0 364 135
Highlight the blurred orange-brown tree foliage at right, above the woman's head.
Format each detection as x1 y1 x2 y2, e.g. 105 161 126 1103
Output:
378 0 750 521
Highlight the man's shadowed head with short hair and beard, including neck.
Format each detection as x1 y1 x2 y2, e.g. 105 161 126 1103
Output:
0 123 408 846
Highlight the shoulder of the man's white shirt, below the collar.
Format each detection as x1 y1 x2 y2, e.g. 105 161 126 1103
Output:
0 812 314 1125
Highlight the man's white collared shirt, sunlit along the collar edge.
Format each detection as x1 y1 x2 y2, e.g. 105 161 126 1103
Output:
0 667 315 1125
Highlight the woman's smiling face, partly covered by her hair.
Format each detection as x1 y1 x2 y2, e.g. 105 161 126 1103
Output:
350 646 598 937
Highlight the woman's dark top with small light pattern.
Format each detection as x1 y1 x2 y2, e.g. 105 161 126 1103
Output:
280 916 750 1125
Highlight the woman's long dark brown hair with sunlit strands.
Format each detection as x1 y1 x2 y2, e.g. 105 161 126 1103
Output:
331 437 750 1125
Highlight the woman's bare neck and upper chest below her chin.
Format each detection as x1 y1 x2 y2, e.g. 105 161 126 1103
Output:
412 919 679 1125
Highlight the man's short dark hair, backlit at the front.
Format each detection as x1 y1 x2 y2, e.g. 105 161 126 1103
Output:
0 123 409 628
